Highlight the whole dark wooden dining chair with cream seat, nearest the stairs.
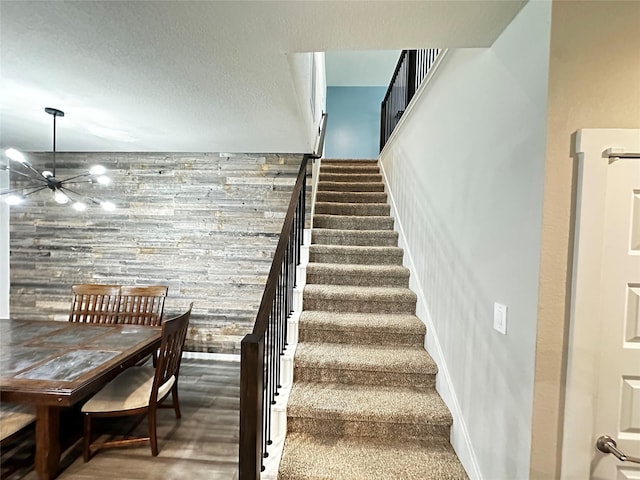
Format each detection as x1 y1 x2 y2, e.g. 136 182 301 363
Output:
82 303 193 462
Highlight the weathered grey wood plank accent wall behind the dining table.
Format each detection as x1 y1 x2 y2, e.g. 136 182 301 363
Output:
10 153 302 353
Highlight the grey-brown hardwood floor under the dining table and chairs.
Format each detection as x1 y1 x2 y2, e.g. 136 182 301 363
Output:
2 358 240 480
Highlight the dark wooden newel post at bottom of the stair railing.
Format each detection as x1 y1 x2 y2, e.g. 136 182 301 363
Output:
238 334 264 480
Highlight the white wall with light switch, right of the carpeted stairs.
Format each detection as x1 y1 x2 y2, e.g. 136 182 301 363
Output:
381 2 551 480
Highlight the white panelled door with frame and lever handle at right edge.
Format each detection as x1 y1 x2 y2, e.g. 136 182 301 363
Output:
562 129 640 480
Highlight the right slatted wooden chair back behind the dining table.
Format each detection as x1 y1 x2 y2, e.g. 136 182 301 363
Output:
118 285 169 326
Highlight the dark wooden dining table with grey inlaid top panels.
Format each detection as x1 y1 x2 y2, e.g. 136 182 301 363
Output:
0 319 161 480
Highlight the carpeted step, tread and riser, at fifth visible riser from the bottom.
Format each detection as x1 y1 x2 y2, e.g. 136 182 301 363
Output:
307 263 409 287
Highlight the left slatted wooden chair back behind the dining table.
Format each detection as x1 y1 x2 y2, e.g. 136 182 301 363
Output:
69 284 120 323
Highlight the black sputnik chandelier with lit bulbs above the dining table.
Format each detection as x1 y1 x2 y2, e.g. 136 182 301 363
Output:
0 107 115 212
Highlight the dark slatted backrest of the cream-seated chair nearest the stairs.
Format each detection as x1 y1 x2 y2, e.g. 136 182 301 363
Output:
150 303 193 403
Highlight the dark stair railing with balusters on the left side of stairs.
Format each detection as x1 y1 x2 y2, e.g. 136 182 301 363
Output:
238 113 327 480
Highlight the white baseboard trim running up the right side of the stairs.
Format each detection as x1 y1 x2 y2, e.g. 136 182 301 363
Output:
380 162 482 480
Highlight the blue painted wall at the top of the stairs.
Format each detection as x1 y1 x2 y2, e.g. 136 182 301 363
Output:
324 87 387 158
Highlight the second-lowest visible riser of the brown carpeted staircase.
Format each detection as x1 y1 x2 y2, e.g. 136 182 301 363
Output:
294 366 436 389
